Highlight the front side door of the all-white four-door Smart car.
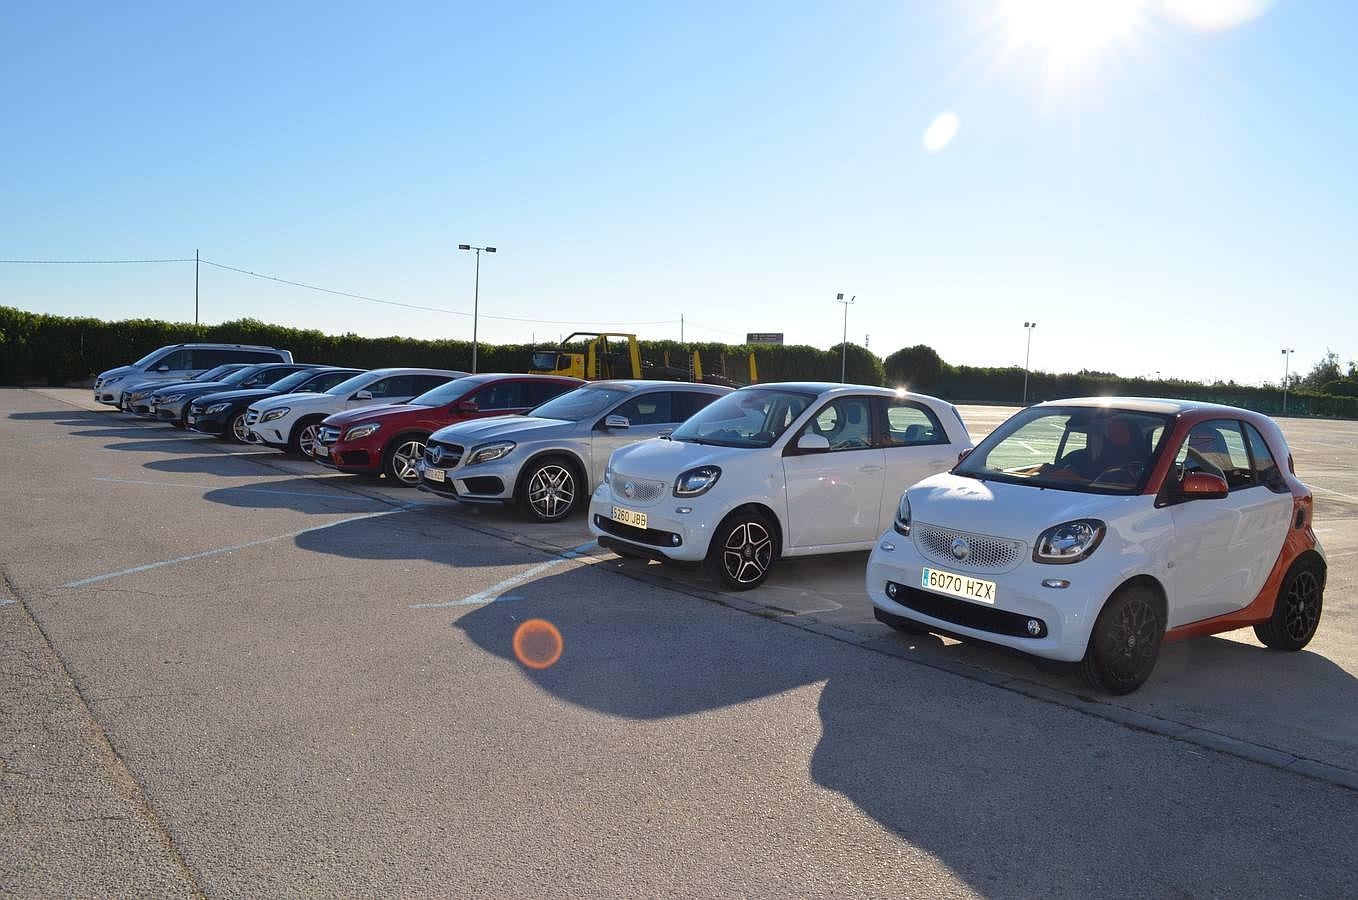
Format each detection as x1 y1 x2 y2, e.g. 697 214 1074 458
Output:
782 395 885 550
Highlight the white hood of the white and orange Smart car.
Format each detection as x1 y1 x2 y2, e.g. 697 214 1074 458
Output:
906 472 1148 543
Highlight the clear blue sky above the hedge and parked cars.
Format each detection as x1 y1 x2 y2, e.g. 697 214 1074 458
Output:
0 0 1358 381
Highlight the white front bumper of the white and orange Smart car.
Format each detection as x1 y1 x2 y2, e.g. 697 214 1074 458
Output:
865 531 1114 662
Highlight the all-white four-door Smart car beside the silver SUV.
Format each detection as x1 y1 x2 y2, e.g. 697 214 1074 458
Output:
589 383 971 590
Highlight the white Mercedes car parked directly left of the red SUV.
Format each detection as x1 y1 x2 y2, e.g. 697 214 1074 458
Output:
246 369 466 456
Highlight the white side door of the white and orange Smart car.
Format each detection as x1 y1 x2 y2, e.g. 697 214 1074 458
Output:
1169 419 1291 627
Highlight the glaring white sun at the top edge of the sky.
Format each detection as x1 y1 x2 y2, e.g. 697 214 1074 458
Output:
1001 0 1146 64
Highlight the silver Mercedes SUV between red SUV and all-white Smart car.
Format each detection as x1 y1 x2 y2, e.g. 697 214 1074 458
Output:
416 381 731 521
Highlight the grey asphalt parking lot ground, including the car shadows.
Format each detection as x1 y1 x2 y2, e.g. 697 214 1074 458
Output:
0 391 1358 897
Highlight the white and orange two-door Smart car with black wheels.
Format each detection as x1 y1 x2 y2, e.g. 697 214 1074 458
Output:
866 398 1325 694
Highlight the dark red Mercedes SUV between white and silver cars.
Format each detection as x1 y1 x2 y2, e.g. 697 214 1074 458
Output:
315 375 584 487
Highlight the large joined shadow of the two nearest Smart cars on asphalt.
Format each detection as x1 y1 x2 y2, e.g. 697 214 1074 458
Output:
450 567 1355 896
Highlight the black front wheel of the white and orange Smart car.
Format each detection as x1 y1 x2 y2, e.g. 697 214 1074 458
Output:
1080 585 1165 695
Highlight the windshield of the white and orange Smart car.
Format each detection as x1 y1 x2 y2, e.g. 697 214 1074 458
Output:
953 406 1171 494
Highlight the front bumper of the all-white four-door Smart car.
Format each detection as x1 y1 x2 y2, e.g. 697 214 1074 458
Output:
589 485 721 565
